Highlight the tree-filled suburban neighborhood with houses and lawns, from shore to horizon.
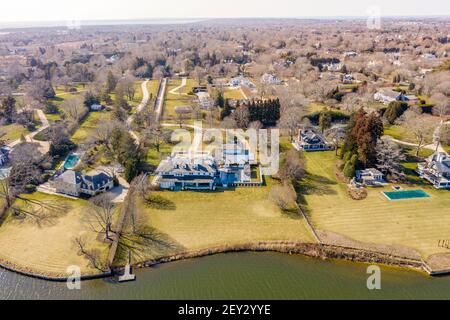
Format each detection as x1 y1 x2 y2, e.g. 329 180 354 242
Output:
0 3 450 302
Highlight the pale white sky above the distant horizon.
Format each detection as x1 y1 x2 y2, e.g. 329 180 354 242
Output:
0 0 450 23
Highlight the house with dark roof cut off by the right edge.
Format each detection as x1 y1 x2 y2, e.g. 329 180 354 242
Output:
417 152 450 189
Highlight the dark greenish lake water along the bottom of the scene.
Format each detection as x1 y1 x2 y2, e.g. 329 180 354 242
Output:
0 253 450 299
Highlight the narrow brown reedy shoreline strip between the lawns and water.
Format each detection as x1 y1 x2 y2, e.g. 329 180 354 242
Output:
0 241 442 282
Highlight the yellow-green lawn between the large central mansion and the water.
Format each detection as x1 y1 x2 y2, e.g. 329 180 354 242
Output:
125 180 313 259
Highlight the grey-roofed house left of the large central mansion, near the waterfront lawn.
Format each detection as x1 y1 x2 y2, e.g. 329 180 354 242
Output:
52 170 114 197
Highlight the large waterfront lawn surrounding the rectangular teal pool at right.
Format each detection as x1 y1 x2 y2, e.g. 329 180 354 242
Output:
301 152 450 259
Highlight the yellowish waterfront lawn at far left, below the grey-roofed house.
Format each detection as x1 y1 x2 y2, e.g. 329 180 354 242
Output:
0 193 108 276
